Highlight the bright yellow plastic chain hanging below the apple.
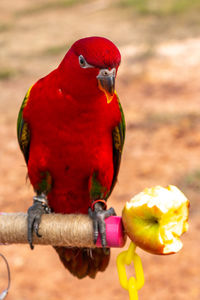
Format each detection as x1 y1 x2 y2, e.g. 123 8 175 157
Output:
117 242 144 300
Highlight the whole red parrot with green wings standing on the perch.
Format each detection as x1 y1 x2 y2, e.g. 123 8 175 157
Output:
17 37 125 278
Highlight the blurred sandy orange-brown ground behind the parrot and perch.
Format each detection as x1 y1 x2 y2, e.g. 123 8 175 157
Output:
0 0 200 300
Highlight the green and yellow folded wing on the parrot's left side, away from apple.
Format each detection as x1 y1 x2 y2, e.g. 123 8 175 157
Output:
17 87 32 164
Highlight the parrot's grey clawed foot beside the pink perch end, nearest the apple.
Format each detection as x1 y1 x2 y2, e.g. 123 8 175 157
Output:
88 202 116 251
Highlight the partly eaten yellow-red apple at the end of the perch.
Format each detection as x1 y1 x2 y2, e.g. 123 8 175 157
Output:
122 185 189 254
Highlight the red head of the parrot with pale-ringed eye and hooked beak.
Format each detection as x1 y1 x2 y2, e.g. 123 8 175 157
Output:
59 37 121 103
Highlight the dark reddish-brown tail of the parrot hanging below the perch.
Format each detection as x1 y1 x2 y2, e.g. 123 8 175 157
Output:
54 247 110 279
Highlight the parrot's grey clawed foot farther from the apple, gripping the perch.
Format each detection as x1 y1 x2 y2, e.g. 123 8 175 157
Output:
28 194 51 249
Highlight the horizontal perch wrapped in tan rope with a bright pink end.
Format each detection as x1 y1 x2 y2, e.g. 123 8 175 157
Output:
0 213 125 248
